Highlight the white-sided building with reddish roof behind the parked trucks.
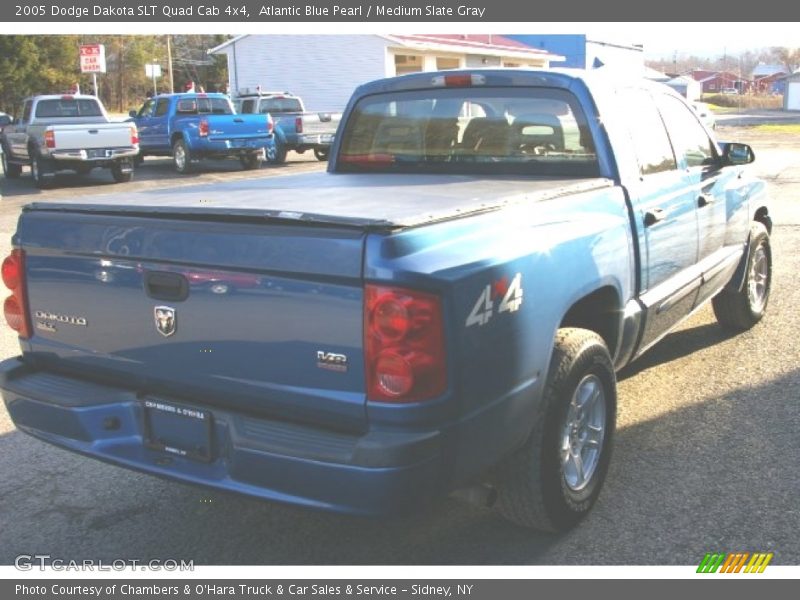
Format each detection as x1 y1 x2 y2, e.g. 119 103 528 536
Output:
208 34 564 110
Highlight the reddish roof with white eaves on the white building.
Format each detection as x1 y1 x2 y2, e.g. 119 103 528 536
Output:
208 33 565 62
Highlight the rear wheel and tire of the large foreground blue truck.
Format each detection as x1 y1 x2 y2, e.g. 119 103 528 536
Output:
495 328 617 532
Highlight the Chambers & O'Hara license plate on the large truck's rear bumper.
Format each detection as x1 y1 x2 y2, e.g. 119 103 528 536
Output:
142 398 214 463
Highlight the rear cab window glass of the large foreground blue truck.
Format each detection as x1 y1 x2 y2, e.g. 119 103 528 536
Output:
338 87 599 177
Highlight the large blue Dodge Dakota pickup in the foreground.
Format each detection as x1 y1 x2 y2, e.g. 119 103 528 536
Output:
0 70 772 531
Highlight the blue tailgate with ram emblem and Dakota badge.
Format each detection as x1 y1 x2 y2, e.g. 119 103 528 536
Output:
18 210 365 430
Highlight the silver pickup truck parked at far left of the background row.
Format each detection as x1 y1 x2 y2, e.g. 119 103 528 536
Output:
0 95 139 188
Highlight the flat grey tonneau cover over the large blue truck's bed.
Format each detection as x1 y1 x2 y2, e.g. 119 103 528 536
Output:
30 173 613 229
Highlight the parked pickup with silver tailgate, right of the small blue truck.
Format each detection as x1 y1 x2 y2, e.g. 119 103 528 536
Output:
235 90 342 163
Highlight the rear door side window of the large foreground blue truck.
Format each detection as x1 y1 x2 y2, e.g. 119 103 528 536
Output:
618 89 678 175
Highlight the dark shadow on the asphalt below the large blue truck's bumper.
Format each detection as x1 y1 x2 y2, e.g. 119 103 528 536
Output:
0 364 800 565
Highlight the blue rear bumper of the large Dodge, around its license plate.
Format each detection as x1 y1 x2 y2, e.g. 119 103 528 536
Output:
0 359 446 515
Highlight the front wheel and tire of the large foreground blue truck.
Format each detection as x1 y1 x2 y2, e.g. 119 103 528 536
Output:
711 222 772 331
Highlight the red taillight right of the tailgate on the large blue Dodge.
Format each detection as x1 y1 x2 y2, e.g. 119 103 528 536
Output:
364 285 447 402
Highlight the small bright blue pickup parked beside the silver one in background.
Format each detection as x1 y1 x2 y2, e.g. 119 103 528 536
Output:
130 92 275 173
